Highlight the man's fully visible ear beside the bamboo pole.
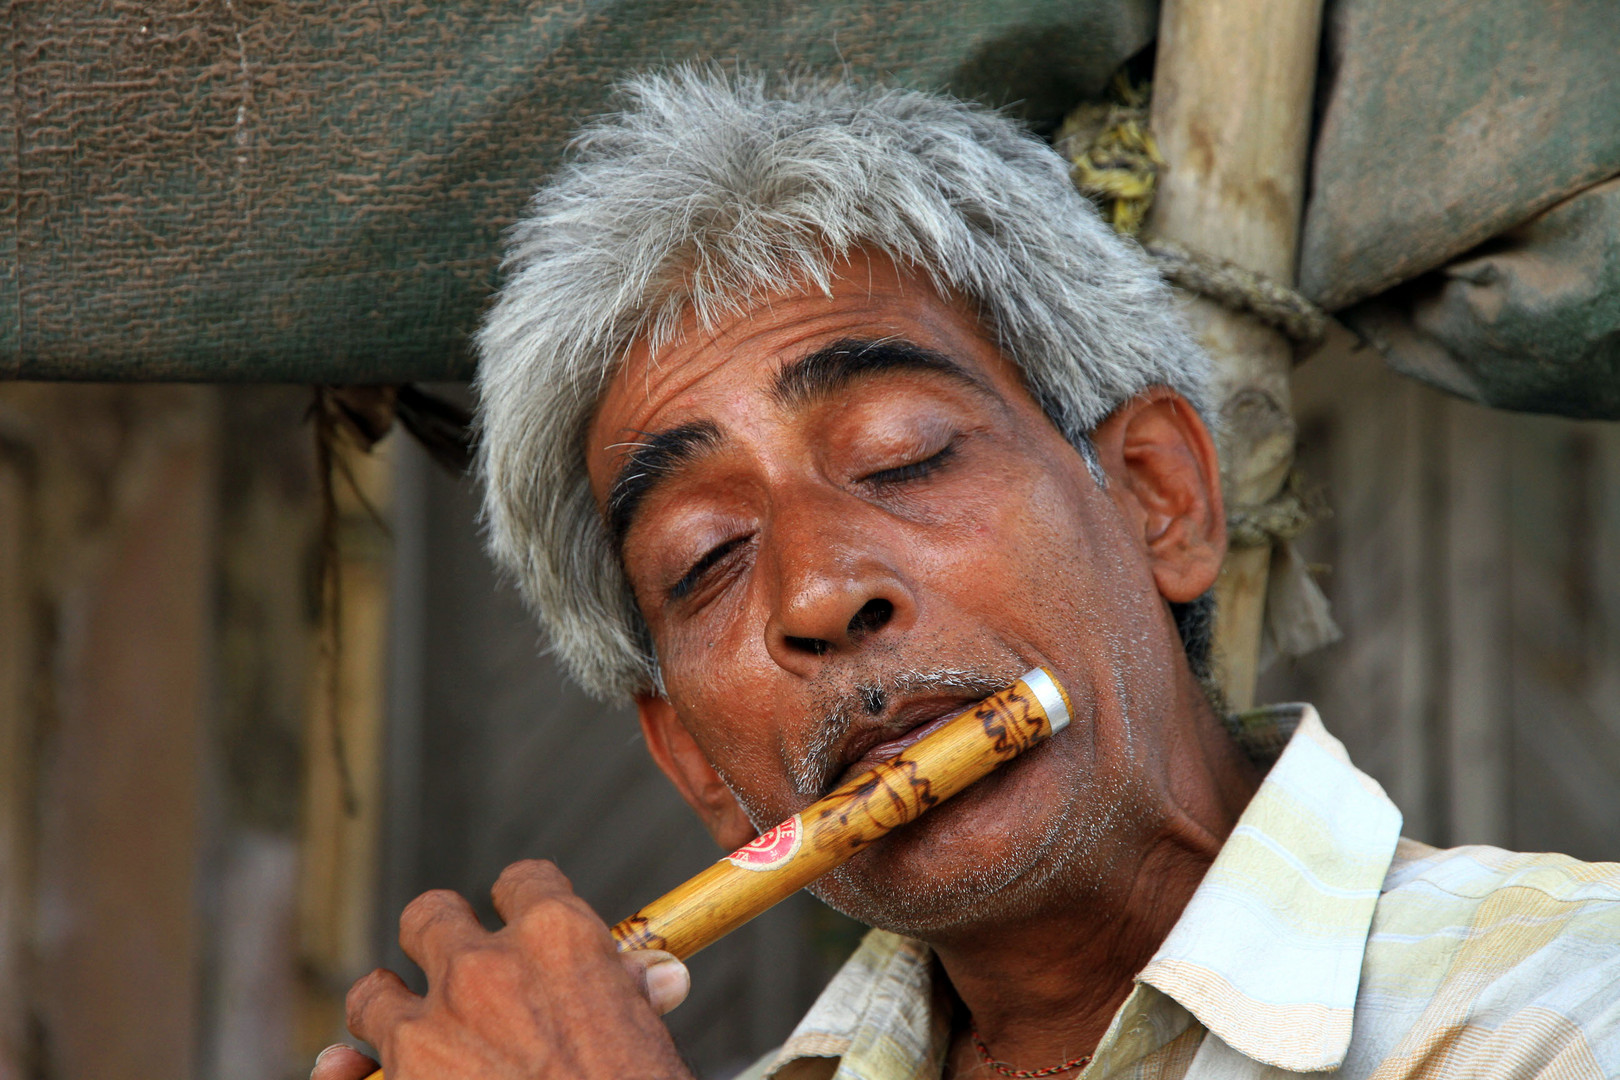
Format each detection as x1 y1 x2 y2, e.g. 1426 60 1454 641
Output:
1092 387 1226 604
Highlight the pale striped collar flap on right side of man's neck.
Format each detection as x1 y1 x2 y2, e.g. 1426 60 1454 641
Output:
1137 706 1401 1072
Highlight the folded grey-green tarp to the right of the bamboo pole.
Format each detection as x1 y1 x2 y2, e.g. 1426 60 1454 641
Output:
1299 0 1620 418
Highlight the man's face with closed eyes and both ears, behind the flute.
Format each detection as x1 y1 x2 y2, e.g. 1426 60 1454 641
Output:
586 256 1221 933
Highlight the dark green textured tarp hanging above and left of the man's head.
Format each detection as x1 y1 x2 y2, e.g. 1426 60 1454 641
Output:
0 0 1157 382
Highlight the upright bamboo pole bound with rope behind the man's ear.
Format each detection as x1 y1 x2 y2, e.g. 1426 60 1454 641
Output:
1149 0 1322 708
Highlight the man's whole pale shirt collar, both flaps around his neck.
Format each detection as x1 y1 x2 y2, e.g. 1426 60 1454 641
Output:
766 706 1401 1080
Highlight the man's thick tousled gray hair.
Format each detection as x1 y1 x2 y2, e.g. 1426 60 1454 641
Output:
476 68 1209 698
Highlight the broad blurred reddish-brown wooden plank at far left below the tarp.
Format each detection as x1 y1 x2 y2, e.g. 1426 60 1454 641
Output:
32 385 217 1080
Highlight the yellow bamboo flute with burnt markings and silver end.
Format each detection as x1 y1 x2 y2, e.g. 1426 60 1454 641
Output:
368 667 1069 1080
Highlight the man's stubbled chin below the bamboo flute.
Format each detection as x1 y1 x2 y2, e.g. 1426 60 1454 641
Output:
810 761 1129 939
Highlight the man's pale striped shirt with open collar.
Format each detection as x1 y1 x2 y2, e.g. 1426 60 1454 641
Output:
744 706 1620 1080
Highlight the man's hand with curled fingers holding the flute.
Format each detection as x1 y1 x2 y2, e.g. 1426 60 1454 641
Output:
309 861 690 1080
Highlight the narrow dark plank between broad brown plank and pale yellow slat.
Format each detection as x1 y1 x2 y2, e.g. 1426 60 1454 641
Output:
210 387 337 1080
